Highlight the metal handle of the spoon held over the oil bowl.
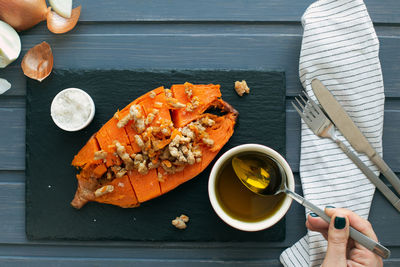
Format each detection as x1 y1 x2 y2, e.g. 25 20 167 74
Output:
284 189 390 259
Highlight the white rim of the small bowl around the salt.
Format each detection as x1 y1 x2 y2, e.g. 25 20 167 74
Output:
50 88 95 132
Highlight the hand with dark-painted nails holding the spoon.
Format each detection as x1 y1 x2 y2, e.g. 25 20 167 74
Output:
306 207 383 267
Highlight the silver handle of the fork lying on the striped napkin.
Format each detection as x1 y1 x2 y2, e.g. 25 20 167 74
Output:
335 139 400 212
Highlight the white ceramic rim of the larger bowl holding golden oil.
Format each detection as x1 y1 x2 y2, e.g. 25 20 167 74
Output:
208 144 294 232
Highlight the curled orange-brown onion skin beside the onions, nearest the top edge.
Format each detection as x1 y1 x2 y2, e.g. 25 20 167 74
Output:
47 6 81 33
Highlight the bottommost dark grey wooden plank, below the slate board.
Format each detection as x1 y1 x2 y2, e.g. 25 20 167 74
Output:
0 244 283 263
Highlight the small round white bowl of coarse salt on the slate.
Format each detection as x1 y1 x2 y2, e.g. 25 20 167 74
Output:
51 88 94 130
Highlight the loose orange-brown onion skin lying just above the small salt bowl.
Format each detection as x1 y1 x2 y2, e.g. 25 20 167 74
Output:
21 42 54 82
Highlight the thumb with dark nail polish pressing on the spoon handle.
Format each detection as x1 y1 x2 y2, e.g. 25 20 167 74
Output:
322 212 349 267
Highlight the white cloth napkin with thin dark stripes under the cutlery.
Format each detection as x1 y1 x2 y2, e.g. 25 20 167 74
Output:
280 0 385 266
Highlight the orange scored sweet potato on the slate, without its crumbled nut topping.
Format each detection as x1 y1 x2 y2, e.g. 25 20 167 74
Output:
71 83 238 209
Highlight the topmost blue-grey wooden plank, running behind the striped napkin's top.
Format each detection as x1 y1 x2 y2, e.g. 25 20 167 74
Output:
60 0 400 23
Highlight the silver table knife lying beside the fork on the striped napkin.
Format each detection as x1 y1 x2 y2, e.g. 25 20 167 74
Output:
311 79 400 194
